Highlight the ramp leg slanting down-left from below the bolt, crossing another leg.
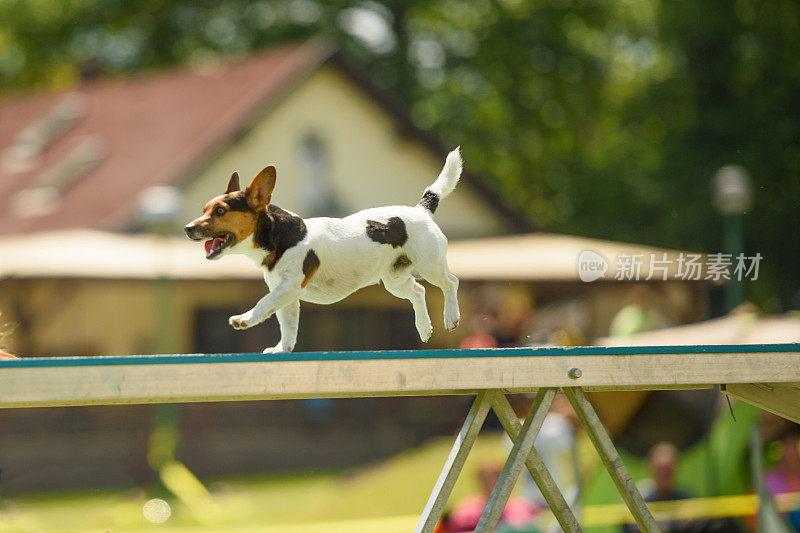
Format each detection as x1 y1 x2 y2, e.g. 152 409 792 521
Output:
475 389 556 533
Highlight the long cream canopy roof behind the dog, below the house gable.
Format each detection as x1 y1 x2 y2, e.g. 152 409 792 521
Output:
0 230 700 283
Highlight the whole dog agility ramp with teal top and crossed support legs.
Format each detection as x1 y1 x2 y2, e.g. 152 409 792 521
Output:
0 344 800 533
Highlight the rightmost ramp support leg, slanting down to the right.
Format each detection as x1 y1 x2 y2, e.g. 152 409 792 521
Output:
563 387 660 533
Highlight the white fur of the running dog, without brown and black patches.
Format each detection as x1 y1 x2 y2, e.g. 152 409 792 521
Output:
220 148 462 353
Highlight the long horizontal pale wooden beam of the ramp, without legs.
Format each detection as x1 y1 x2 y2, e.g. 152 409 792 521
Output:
0 350 800 407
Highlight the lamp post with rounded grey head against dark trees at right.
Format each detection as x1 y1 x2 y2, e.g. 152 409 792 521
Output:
712 165 753 312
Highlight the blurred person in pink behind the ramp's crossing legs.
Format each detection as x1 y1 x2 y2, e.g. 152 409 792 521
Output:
436 463 541 533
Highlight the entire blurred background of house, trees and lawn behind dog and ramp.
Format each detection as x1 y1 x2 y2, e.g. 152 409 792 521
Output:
0 0 800 531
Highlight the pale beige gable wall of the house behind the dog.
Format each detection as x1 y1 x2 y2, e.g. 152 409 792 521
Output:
183 67 509 238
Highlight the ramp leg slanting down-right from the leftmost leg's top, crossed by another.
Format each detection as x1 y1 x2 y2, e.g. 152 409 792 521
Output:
492 391 582 533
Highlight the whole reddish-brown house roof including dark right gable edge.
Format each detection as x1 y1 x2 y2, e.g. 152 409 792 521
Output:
0 41 530 234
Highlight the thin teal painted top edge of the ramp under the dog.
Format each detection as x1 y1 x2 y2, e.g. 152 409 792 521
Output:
0 343 800 368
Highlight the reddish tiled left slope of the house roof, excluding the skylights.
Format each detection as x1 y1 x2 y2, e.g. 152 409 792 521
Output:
0 42 329 234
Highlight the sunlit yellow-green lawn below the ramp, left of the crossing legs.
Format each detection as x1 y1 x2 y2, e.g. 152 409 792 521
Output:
0 434 508 533
